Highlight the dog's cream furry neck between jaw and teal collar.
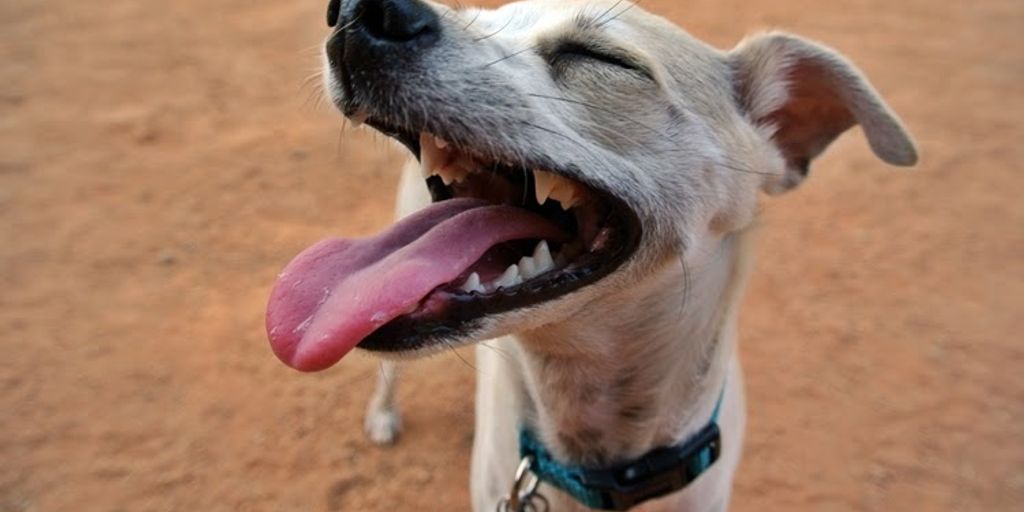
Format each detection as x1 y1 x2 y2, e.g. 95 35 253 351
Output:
517 234 748 465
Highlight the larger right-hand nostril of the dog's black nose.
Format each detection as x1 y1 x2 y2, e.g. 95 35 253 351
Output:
356 0 438 42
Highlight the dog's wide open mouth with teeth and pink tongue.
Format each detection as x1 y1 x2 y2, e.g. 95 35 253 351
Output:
266 120 640 371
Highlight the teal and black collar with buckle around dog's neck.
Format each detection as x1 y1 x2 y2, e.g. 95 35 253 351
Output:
519 385 725 510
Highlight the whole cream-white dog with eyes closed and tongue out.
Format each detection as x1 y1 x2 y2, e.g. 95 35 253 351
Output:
267 0 918 511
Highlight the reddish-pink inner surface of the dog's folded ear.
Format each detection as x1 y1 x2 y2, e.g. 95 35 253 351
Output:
759 59 857 174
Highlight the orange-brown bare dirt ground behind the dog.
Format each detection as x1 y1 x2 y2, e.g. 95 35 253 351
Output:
0 0 1024 512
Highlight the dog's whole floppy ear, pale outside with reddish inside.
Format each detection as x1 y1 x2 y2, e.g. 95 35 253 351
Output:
729 33 918 194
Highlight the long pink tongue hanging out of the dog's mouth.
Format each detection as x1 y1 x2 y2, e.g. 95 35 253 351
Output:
266 199 564 372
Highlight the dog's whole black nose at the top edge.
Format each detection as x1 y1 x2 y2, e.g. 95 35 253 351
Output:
328 0 439 44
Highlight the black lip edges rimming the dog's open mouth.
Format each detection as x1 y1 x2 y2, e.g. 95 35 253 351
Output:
345 114 643 353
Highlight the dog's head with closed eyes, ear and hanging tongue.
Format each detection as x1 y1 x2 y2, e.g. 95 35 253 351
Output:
267 0 916 370
